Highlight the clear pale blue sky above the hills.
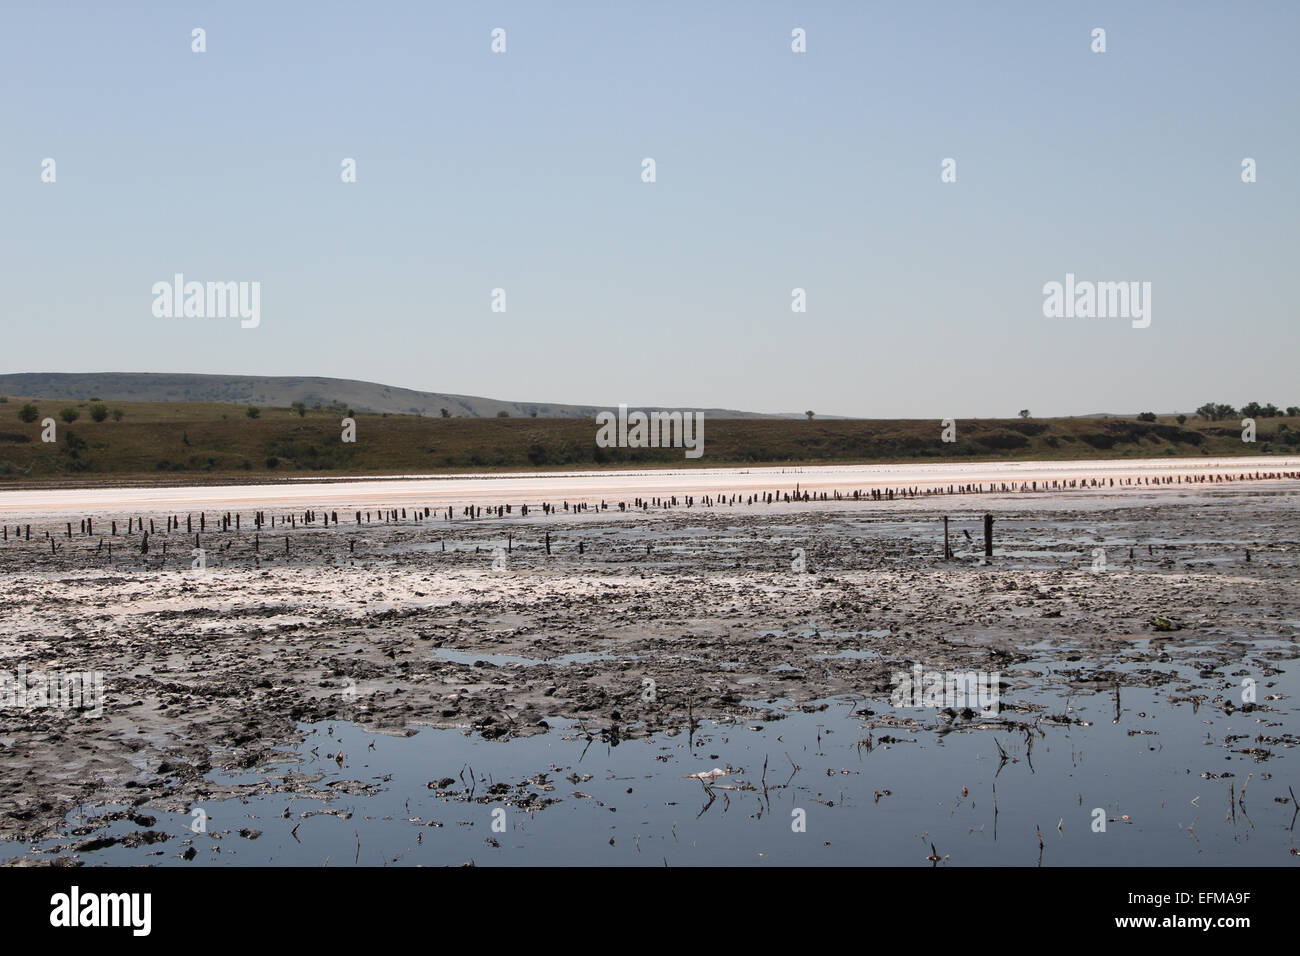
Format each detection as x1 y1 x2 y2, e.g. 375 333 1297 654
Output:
0 0 1300 418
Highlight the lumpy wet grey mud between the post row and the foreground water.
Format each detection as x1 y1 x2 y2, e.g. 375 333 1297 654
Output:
0 483 1300 865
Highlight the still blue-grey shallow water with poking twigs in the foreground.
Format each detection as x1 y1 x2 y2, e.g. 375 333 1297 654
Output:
0 639 1300 866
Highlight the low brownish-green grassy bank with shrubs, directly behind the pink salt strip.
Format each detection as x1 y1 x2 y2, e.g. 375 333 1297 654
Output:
0 397 1300 484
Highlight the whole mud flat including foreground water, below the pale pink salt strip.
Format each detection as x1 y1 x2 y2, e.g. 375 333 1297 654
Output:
0 478 1300 866
